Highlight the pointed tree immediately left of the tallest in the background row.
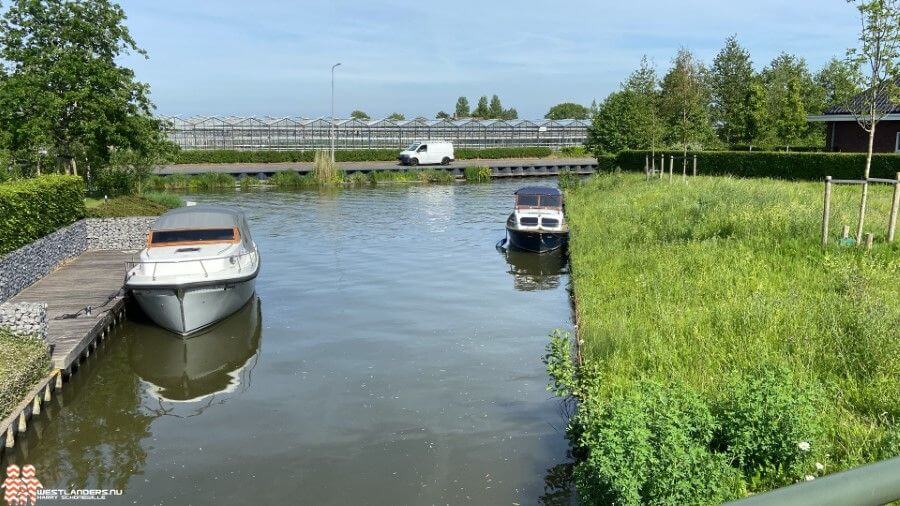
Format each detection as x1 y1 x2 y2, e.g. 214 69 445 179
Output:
660 49 715 157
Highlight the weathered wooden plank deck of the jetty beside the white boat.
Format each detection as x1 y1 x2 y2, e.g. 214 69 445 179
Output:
10 251 134 370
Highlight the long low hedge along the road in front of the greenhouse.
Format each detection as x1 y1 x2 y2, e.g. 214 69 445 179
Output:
175 147 550 164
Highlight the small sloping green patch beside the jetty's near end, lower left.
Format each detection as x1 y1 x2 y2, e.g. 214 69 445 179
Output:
0 329 50 419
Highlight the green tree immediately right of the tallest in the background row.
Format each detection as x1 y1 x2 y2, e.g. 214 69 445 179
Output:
761 53 825 146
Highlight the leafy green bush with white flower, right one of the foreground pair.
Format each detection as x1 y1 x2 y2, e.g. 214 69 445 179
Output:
715 367 823 490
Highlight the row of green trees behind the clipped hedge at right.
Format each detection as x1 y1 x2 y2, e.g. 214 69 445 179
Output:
588 36 863 153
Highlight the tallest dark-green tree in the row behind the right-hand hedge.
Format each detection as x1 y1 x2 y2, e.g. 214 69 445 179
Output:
710 36 753 144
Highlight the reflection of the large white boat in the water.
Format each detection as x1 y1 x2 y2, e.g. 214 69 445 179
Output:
128 297 262 402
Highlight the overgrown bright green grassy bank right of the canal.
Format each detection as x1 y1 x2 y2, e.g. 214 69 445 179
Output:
547 174 900 503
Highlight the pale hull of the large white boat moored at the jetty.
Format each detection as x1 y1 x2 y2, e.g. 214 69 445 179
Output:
131 276 256 335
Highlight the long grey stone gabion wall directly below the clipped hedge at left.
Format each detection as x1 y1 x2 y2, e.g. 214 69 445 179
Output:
0 220 87 302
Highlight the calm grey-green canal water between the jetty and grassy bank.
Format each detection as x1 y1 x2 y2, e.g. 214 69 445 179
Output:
5 180 570 504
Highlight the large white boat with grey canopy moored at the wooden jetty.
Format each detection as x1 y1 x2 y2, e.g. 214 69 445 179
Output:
125 206 260 335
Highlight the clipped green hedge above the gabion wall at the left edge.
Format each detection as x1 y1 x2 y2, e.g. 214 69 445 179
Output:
0 175 85 255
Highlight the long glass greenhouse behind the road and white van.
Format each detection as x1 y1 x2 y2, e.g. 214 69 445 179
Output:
164 116 590 151
